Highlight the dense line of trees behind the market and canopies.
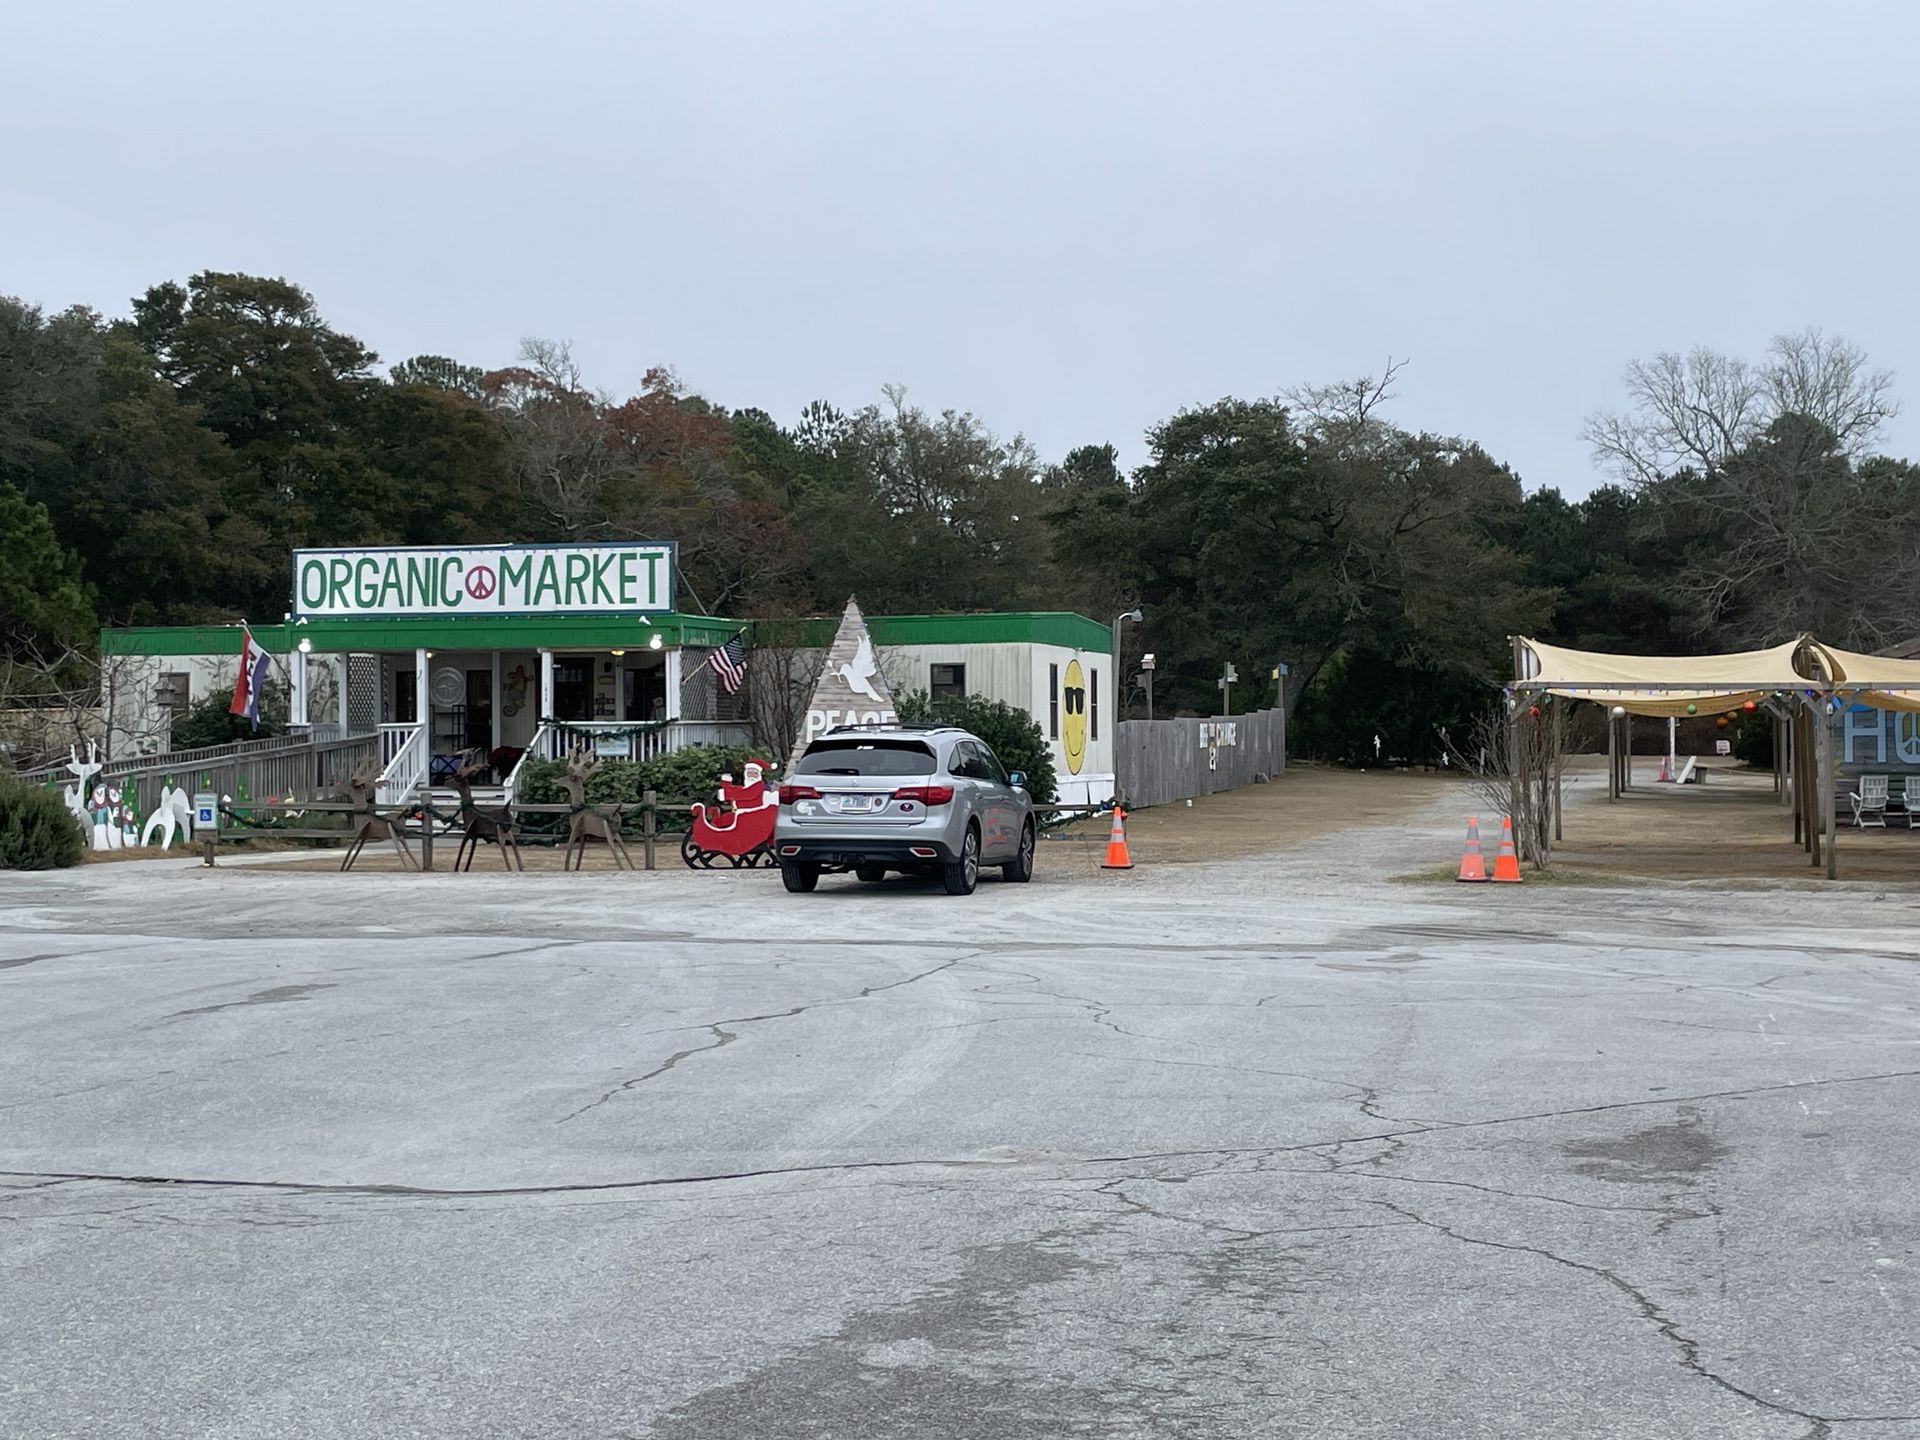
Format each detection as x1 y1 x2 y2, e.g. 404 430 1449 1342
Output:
0 273 1920 758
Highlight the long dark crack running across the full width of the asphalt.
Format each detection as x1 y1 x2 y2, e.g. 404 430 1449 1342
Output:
0 1067 1920 1204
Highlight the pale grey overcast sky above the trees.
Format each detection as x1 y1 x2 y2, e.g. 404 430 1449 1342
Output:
0 0 1920 492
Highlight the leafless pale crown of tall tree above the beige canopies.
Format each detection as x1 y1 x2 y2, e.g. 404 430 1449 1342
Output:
1586 328 1899 486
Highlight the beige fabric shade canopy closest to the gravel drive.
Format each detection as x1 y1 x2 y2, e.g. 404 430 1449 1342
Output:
1521 637 1812 716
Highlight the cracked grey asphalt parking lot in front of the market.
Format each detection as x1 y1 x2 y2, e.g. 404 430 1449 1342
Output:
0 785 1920 1440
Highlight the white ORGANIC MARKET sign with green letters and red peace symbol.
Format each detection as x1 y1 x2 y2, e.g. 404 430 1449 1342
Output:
294 543 674 616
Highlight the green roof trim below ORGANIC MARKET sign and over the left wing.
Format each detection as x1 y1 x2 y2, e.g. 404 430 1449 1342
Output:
100 612 743 655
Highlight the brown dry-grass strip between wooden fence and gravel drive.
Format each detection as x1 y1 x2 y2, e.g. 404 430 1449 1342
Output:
1043 764 1469 864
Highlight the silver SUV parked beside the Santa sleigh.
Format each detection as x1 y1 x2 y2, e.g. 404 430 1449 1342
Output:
774 726 1033 895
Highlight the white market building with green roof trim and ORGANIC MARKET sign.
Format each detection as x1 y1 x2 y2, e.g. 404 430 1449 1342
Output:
100 541 1117 801
